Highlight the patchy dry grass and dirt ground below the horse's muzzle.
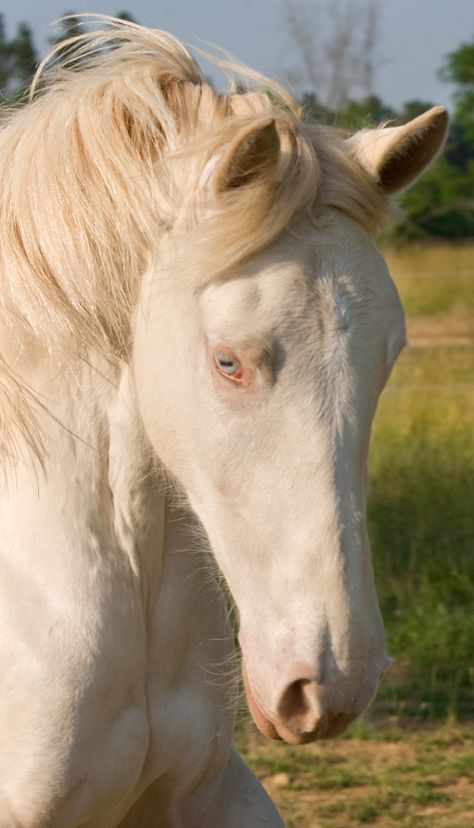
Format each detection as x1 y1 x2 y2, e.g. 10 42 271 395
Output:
240 724 474 828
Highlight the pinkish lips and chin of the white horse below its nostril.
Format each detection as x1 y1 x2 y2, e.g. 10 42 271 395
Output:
242 663 357 745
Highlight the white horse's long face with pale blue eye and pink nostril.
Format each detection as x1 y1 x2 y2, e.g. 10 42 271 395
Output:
134 211 404 742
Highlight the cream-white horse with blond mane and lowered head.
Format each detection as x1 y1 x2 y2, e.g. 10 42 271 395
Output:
0 17 447 828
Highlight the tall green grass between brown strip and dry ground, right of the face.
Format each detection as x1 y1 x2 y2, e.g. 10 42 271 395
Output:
369 346 474 716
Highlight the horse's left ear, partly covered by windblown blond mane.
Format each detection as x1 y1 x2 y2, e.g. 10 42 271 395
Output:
212 118 280 195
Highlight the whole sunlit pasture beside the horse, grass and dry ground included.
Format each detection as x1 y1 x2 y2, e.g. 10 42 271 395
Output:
240 245 474 828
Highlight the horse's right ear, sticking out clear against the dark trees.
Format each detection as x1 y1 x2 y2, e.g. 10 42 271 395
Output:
348 106 448 195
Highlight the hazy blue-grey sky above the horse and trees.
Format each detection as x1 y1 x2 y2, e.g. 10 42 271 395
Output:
0 0 474 108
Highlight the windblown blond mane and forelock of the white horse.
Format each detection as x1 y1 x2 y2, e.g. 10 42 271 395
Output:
0 16 387 460
